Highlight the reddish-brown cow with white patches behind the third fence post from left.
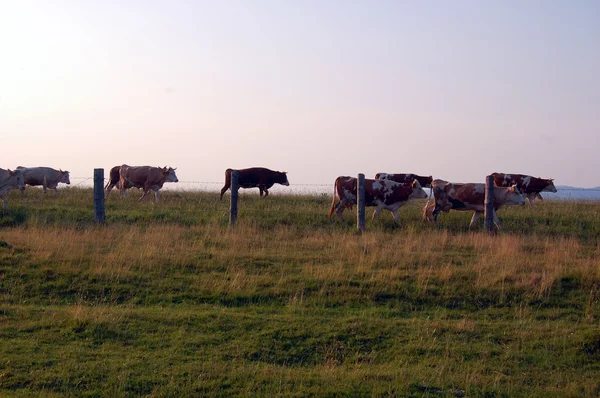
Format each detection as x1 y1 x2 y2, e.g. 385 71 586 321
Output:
329 176 427 224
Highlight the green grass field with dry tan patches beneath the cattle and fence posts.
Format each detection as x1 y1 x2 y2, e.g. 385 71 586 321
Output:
0 188 600 397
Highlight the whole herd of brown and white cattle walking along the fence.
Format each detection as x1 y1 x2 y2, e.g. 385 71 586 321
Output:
0 164 556 228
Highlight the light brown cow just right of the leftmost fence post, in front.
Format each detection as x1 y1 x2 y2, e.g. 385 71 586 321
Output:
119 164 179 201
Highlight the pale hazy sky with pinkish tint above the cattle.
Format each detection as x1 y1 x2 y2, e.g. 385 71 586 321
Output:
0 0 600 187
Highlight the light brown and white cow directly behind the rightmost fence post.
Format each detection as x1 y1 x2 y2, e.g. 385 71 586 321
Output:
424 180 525 229
